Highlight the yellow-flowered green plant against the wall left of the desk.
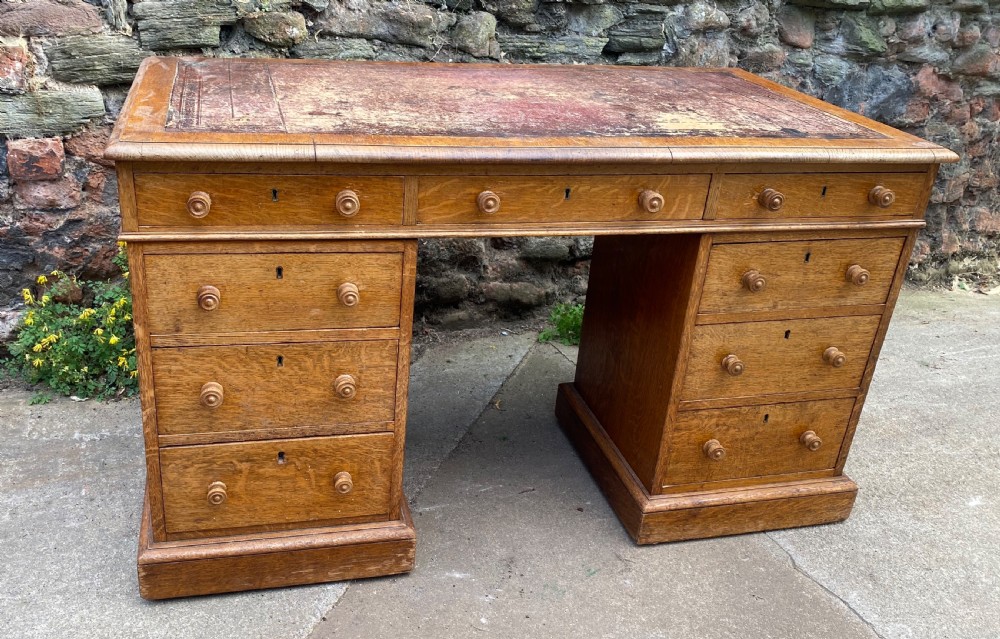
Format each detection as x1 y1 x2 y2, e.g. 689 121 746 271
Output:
7 243 138 401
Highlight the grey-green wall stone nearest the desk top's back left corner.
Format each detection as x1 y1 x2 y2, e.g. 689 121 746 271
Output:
45 35 151 85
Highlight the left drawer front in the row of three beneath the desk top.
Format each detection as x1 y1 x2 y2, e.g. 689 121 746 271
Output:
135 173 403 227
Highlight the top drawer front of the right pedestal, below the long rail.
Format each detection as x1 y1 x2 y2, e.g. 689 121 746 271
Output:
699 237 904 313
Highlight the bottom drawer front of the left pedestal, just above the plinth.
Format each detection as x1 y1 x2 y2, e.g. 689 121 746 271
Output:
160 433 393 533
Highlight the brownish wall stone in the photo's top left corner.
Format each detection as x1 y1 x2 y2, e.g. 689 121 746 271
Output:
0 0 102 36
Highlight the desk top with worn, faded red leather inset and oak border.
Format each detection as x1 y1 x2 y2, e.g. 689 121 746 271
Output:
107 58 957 163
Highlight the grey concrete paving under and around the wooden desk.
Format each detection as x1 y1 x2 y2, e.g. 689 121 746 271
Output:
0 292 1000 639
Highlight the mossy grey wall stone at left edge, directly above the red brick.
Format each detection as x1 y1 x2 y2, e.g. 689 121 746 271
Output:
0 87 104 136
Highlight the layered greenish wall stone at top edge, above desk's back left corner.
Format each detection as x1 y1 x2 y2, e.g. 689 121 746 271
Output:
132 0 239 51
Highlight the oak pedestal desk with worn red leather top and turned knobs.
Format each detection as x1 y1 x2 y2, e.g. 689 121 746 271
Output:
107 58 957 599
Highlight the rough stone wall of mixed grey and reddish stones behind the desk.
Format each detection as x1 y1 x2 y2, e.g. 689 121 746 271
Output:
0 0 1000 336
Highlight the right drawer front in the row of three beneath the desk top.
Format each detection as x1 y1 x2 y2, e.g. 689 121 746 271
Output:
715 173 927 219
